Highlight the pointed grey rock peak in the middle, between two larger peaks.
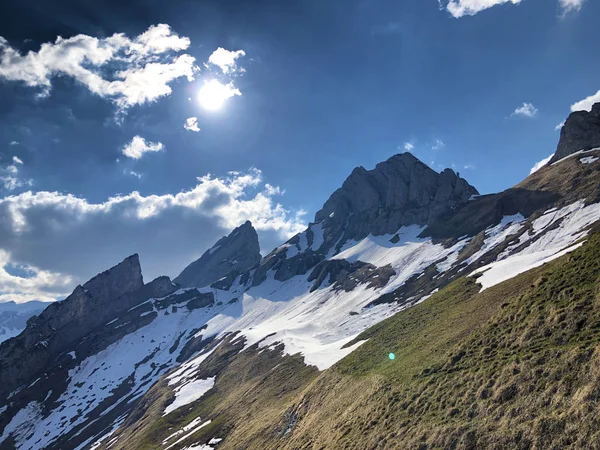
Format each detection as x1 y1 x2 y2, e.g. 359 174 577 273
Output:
174 221 261 287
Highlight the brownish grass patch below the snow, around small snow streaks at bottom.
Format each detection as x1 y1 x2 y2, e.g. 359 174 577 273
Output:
110 336 318 450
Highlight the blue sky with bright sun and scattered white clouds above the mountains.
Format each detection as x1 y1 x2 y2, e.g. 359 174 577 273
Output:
0 0 600 302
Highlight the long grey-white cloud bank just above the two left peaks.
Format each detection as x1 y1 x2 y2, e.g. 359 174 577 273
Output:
0 169 305 293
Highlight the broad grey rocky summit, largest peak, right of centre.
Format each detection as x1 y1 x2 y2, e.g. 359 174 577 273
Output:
315 153 478 251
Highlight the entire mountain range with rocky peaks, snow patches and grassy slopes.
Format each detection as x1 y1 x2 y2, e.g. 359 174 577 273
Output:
0 107 600 450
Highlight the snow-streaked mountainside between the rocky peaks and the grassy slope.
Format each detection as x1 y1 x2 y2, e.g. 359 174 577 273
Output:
0 145 600 449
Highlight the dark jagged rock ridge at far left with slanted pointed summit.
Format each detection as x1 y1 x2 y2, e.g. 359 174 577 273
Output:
0 254 175 395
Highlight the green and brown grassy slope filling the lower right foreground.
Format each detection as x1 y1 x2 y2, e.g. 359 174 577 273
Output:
227 230 600 449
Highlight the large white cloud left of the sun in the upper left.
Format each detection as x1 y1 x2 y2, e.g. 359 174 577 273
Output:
0 24 197 110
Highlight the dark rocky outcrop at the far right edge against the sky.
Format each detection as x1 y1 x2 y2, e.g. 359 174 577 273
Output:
550 103 600 164
